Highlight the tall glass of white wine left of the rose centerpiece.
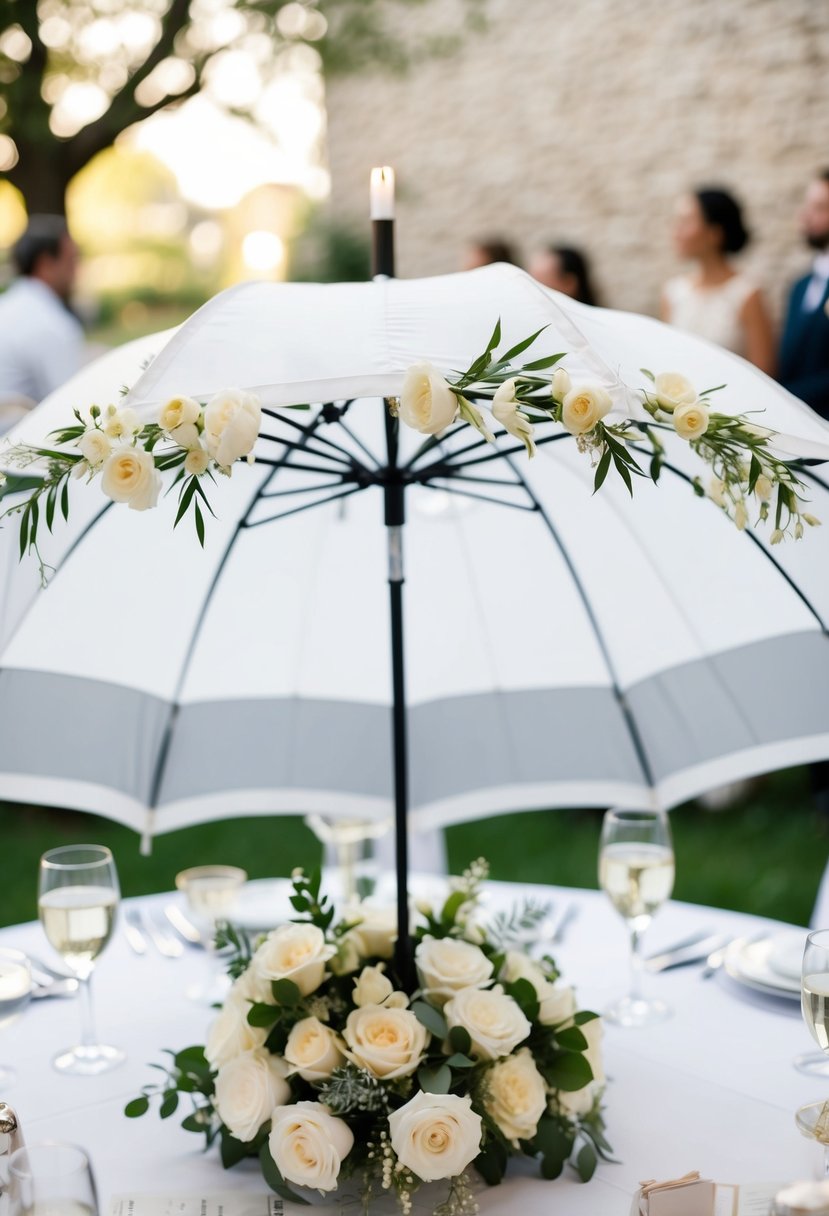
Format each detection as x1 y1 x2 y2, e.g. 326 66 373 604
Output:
38 844 126 1076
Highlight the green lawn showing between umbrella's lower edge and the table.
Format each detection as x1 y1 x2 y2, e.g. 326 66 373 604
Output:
0 769 829 924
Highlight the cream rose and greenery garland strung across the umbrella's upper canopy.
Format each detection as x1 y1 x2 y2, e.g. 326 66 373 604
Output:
0 321 820 575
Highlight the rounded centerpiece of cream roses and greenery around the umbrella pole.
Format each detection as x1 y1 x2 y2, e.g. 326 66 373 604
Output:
126 861 609 1216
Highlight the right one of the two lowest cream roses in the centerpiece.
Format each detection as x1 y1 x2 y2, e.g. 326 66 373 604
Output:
389 1091 481 1182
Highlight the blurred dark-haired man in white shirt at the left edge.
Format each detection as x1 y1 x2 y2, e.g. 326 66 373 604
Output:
0 215 84 430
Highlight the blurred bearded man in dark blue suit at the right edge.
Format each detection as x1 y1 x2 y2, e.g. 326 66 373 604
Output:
778 169 829 420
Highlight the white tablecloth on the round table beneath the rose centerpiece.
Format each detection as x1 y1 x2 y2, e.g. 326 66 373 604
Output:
0 883 829 1216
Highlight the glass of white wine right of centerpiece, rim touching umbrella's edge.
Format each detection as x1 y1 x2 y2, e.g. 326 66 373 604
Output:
599 811 673 1026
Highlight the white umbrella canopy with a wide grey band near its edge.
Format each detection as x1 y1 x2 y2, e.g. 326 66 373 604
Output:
0 266 829 846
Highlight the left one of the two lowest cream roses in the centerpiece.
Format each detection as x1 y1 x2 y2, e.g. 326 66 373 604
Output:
267 1102 354 1190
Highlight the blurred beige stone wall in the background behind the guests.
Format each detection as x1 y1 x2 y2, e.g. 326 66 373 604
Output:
328 0 829 313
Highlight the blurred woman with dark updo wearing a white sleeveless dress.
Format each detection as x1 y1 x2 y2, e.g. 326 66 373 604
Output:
661 188 776 375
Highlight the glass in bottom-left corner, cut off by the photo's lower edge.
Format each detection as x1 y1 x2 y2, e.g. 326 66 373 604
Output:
9 1141 98 1216
